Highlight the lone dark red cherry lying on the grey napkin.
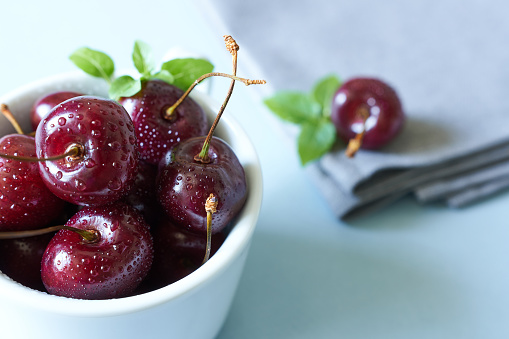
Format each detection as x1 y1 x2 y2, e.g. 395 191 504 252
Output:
331 78 405 149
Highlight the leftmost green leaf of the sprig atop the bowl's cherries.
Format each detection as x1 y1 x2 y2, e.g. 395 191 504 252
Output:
69 47 115 82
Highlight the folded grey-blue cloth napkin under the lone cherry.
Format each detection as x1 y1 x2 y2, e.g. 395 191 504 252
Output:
200 0 509 218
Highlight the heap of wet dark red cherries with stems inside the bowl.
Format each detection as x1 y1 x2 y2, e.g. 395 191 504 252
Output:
0 36 263 299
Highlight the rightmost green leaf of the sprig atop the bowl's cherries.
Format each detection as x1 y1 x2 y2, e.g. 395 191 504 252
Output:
161 58 214 90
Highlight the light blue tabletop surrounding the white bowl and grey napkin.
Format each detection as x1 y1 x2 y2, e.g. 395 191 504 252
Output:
0 0 509 339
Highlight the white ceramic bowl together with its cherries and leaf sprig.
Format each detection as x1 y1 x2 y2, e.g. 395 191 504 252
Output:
0 37 263 338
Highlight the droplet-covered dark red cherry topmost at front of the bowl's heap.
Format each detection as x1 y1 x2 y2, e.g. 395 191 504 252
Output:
35 96 138 206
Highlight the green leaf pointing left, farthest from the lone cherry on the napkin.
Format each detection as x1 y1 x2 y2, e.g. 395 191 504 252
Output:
264 92 321 124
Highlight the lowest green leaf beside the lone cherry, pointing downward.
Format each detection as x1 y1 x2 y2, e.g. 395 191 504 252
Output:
297 119 336 165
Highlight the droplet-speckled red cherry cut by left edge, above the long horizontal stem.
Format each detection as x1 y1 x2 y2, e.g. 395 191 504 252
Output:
0 134 65 231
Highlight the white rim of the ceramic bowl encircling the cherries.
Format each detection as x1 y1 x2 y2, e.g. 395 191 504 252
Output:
0 72 263 317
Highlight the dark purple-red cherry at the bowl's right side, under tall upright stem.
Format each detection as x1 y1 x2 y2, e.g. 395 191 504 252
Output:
157 137 247 233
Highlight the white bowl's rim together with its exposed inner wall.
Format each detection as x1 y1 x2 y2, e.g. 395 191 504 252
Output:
0 72 262 317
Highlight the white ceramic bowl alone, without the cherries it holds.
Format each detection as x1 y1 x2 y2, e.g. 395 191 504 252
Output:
0 73 262 339
